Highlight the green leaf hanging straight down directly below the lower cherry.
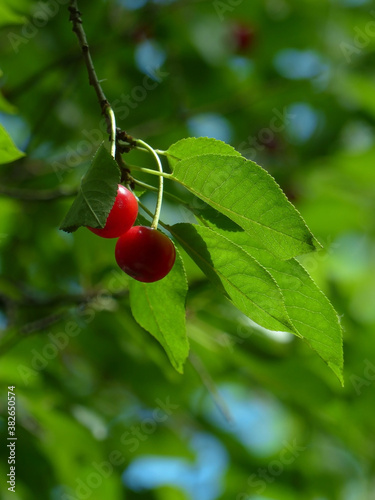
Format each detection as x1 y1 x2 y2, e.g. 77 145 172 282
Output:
129 248 189 373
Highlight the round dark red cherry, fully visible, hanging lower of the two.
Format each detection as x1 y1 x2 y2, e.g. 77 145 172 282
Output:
115 226 176 283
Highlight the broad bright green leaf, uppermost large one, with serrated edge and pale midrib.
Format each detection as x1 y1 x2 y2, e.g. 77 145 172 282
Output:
173 154 319 260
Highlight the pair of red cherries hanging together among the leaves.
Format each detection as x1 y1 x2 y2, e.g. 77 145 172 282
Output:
89 184 176 283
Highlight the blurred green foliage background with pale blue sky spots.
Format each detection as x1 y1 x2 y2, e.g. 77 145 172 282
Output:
0 0 375 500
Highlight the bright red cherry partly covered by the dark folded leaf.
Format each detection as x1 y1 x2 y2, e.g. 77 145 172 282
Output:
89 184 138 238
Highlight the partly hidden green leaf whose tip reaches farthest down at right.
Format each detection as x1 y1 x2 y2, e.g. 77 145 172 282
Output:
201 207 343 383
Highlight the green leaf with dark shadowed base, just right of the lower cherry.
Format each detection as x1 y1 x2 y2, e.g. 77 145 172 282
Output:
169 223 293 331
